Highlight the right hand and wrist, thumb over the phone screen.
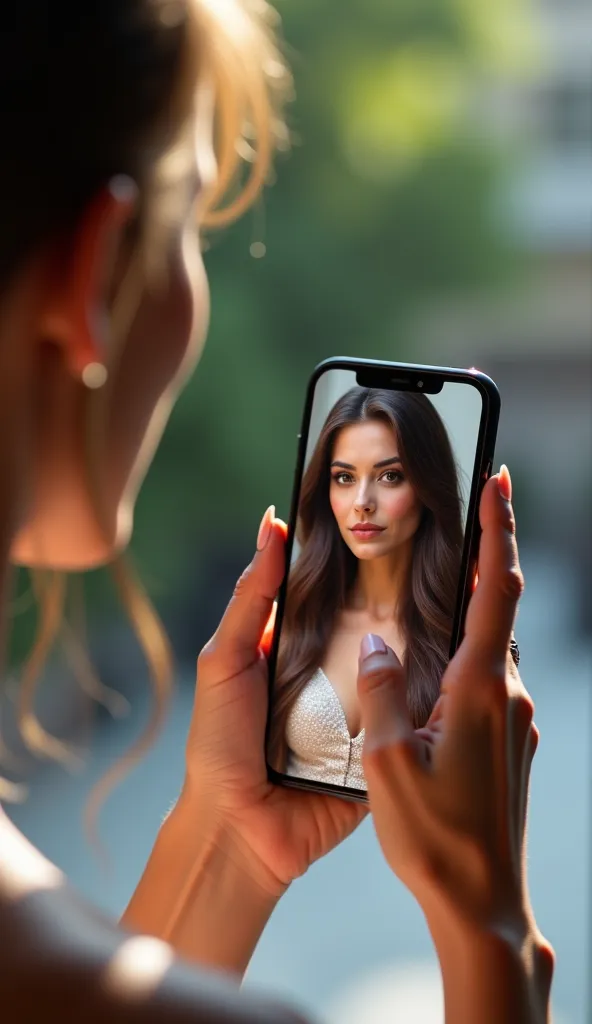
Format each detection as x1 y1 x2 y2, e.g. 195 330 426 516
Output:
358 467 553 1024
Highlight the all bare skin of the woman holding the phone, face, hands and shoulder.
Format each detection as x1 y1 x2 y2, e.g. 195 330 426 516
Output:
0 74 552 1024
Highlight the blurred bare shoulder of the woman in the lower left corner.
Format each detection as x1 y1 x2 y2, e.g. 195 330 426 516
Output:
0 822 304 1024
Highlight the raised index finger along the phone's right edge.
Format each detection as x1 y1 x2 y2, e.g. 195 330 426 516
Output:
464 466 524 672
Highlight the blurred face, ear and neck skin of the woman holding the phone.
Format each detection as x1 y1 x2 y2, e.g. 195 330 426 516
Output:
7 119 215 569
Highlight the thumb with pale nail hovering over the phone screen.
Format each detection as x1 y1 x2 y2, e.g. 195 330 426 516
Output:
357 633 415 752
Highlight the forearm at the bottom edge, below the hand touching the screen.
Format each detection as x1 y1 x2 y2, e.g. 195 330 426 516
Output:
428 914 554 1024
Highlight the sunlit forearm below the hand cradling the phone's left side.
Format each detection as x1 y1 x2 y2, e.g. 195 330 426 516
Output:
122 796 277 976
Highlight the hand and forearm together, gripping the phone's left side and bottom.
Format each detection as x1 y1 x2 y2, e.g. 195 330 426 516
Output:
123 508 367 976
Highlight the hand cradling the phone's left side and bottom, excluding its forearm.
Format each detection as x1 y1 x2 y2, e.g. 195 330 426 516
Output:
183 508 367 896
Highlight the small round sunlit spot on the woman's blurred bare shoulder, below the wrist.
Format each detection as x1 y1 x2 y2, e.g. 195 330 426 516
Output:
102 935 174 999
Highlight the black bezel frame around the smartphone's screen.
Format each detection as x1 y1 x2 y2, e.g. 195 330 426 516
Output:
265 356 501 803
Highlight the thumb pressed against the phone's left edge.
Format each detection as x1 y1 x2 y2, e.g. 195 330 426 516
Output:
203 505 286 679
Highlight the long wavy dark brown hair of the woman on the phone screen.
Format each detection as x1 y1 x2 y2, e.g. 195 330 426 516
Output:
269 387 463 770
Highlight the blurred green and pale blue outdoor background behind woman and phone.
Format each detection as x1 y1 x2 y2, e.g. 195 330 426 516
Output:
0 0 592 1024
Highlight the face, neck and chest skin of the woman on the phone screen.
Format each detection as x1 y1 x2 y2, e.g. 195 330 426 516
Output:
322 420 422 737
